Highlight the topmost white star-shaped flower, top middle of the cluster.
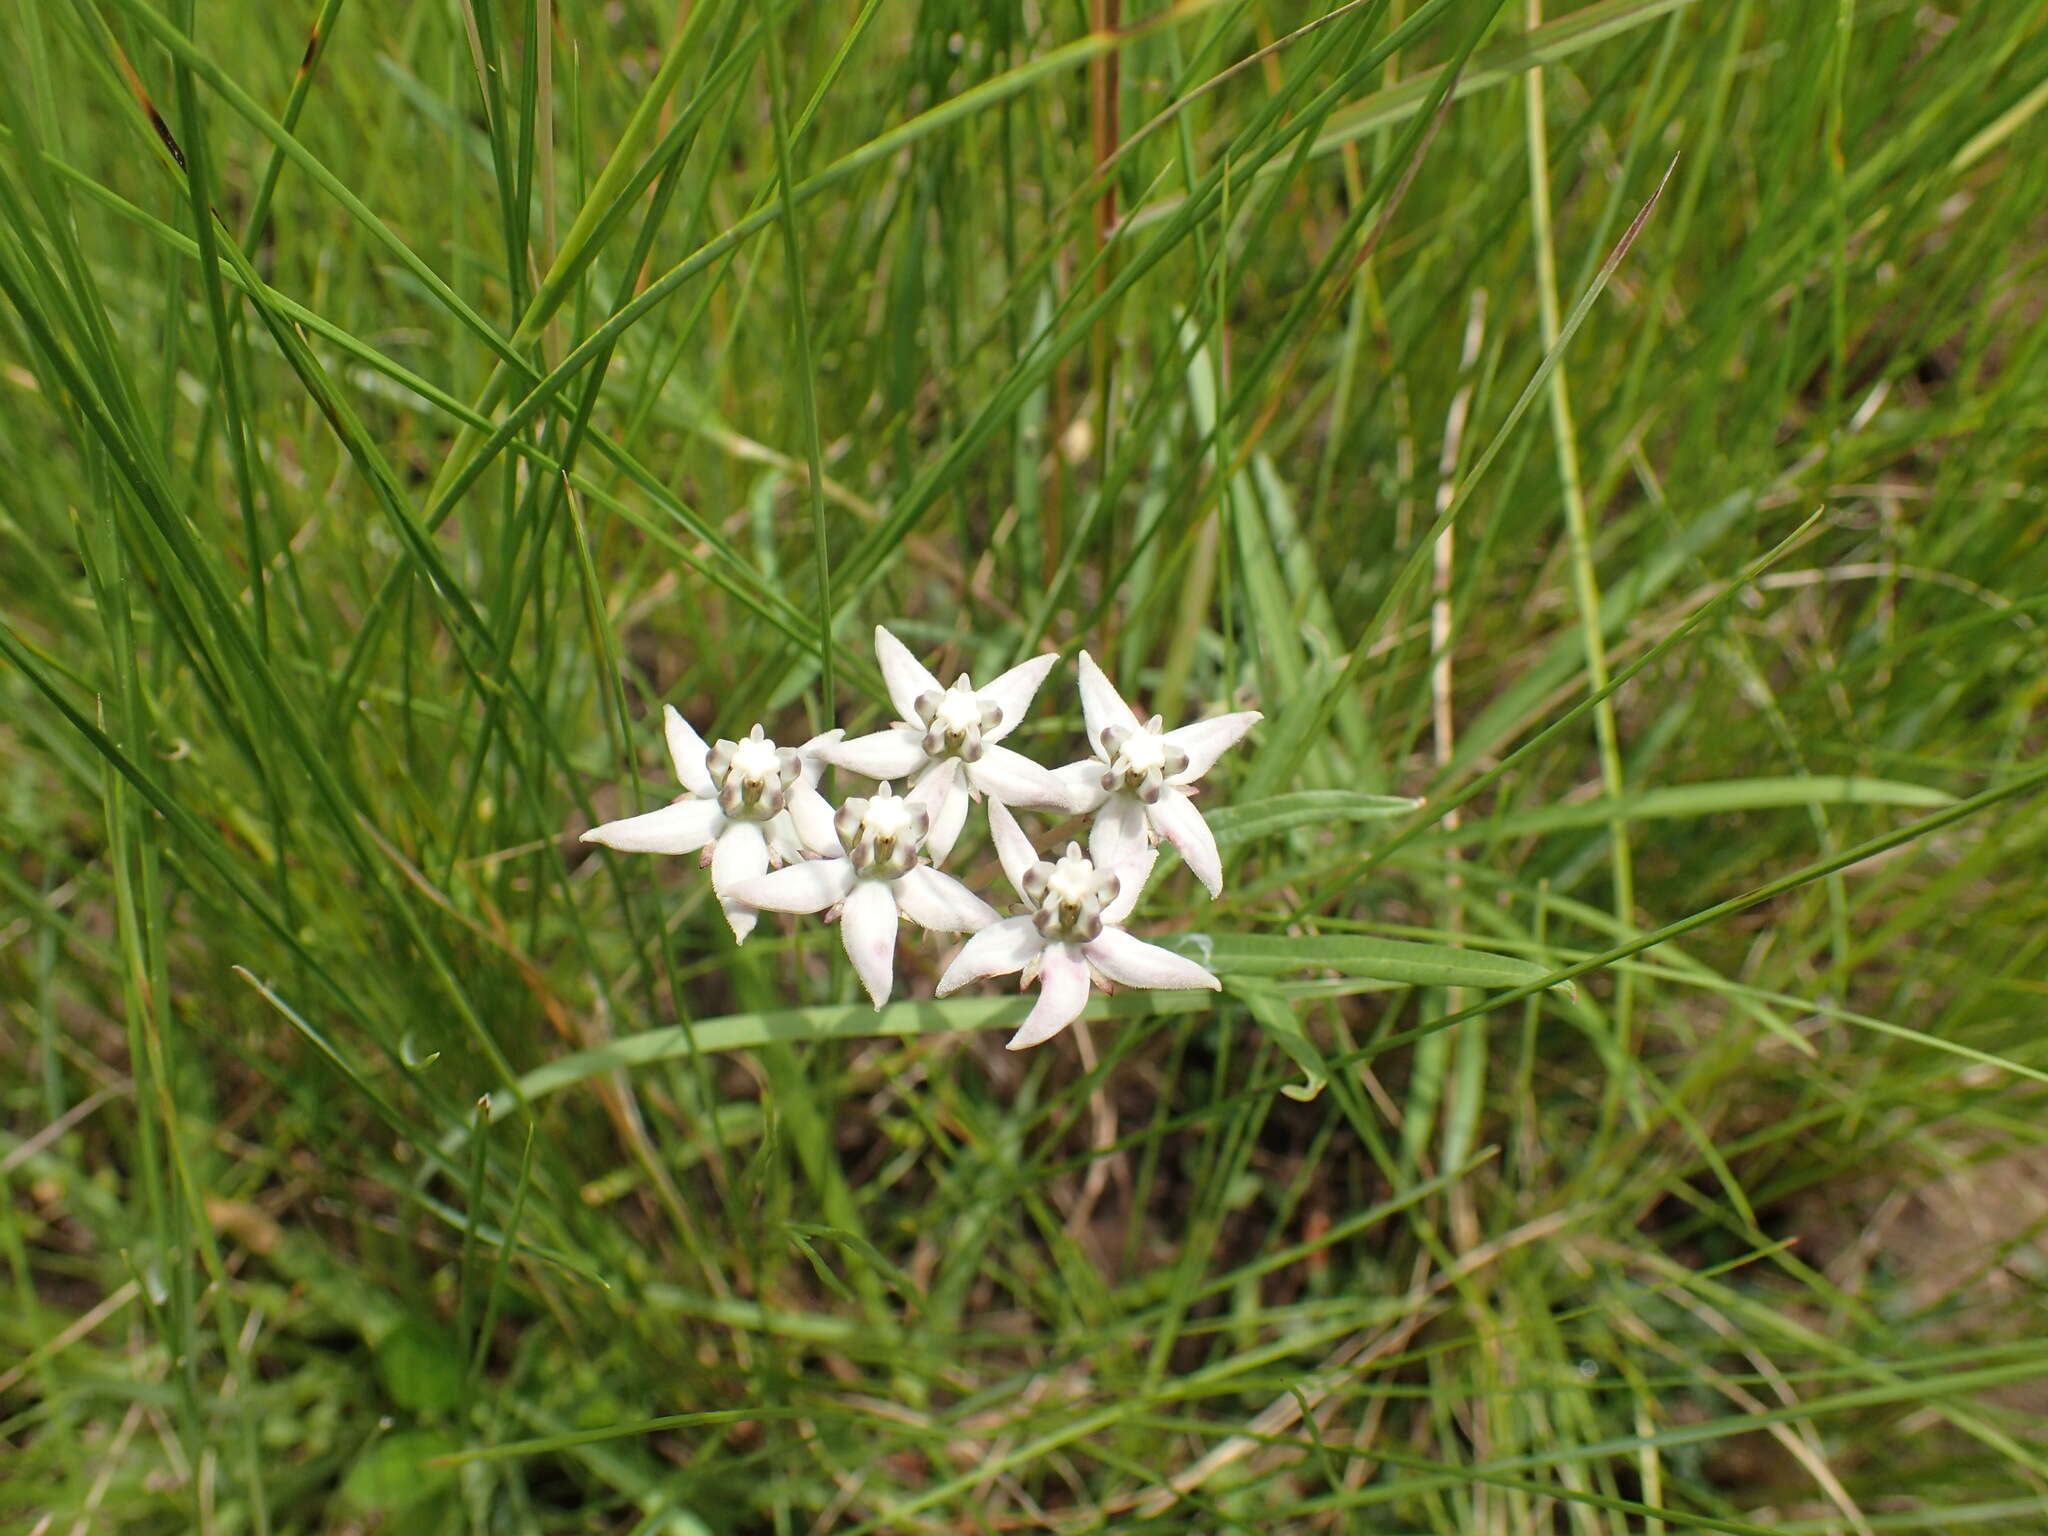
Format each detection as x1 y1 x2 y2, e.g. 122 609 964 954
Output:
819 625 1069 862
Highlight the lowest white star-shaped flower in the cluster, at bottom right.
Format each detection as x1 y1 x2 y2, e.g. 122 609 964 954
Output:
937 803 1223 1051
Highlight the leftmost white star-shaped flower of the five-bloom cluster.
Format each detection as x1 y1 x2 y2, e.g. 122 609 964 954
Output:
584 705 840 940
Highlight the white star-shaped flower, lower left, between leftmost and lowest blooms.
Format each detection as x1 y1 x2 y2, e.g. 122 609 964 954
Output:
733 784 995 1008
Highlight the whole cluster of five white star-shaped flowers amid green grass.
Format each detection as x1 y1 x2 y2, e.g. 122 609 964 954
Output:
584 629 1260 1051
